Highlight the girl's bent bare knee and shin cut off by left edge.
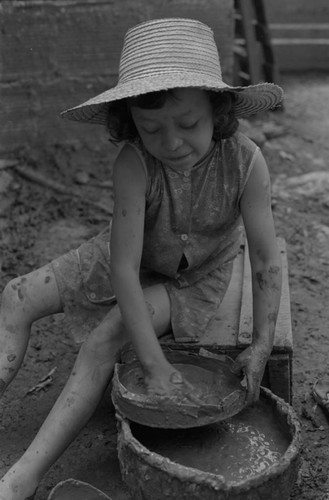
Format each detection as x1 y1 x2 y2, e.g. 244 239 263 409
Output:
0 266 61 399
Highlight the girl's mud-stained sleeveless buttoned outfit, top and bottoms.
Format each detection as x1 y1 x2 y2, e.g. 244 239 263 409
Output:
52 132 259 343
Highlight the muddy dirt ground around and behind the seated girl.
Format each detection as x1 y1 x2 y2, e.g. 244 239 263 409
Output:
0 75 329 500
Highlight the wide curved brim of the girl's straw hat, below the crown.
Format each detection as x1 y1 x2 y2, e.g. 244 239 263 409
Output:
61 72 283 125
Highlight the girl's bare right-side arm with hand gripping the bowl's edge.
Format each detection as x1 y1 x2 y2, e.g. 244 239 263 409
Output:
232 150 281 403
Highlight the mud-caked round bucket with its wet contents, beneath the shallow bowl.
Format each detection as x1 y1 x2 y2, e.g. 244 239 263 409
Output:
118 388 302 500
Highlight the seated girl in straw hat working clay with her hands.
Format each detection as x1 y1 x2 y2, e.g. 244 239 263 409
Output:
0 19 282 500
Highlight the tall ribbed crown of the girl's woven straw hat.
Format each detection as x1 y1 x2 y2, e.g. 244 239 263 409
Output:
119 19 222 83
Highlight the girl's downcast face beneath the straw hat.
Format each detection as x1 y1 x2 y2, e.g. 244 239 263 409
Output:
131 88 214 171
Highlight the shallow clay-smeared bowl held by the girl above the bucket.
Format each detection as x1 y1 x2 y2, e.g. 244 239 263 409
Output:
112 351 245 429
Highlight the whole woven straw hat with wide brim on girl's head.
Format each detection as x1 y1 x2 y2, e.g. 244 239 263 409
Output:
62 18 283 125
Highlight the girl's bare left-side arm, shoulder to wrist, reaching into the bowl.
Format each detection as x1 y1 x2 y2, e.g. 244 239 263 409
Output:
111 146 168 373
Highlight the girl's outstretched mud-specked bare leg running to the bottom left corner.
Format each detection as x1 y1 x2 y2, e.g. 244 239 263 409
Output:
0 285 170 500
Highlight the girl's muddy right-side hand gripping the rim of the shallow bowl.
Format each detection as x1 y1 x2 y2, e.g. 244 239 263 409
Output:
232 343 270 405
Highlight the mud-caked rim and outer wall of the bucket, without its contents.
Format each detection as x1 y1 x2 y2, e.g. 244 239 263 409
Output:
117 388 301 500
